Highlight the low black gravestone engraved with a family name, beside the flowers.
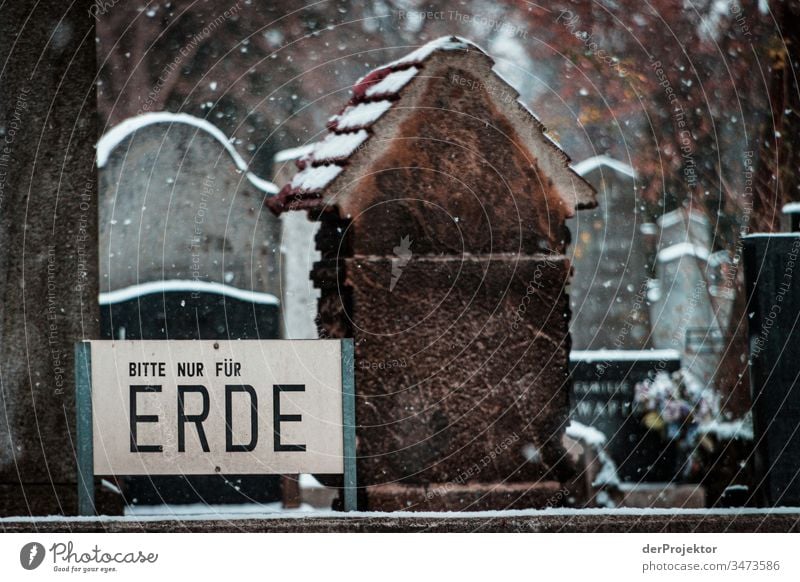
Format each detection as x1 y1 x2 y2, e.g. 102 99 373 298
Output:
570 350 681 482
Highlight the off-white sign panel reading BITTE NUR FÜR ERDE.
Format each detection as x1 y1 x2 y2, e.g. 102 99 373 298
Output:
91 340 344 475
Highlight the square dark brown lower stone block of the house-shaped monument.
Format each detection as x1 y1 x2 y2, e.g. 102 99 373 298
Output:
315 256 569 485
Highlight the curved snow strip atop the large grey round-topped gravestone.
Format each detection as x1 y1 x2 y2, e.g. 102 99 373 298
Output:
97 111 278 194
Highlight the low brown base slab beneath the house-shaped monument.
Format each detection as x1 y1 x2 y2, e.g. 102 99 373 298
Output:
366 481 569 511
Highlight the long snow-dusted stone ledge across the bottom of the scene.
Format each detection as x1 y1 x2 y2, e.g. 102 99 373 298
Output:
0 508 800 533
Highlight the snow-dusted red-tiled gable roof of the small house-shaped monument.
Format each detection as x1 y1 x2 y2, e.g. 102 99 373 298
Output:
266 36 597 214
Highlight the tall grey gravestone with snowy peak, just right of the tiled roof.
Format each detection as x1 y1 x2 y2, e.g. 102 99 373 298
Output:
567 156 653 350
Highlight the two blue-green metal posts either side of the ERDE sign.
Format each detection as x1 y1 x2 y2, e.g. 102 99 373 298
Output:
75 338 358 516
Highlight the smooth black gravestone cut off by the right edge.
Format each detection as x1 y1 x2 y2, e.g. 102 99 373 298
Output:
744 233 800 507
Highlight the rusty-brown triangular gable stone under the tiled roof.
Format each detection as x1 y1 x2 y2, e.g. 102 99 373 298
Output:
336 65 570 255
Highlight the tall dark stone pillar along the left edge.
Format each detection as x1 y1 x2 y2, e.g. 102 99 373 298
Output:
0 0 99 515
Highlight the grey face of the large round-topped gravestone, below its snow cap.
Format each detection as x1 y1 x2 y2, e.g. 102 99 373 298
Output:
100 123 280 296
